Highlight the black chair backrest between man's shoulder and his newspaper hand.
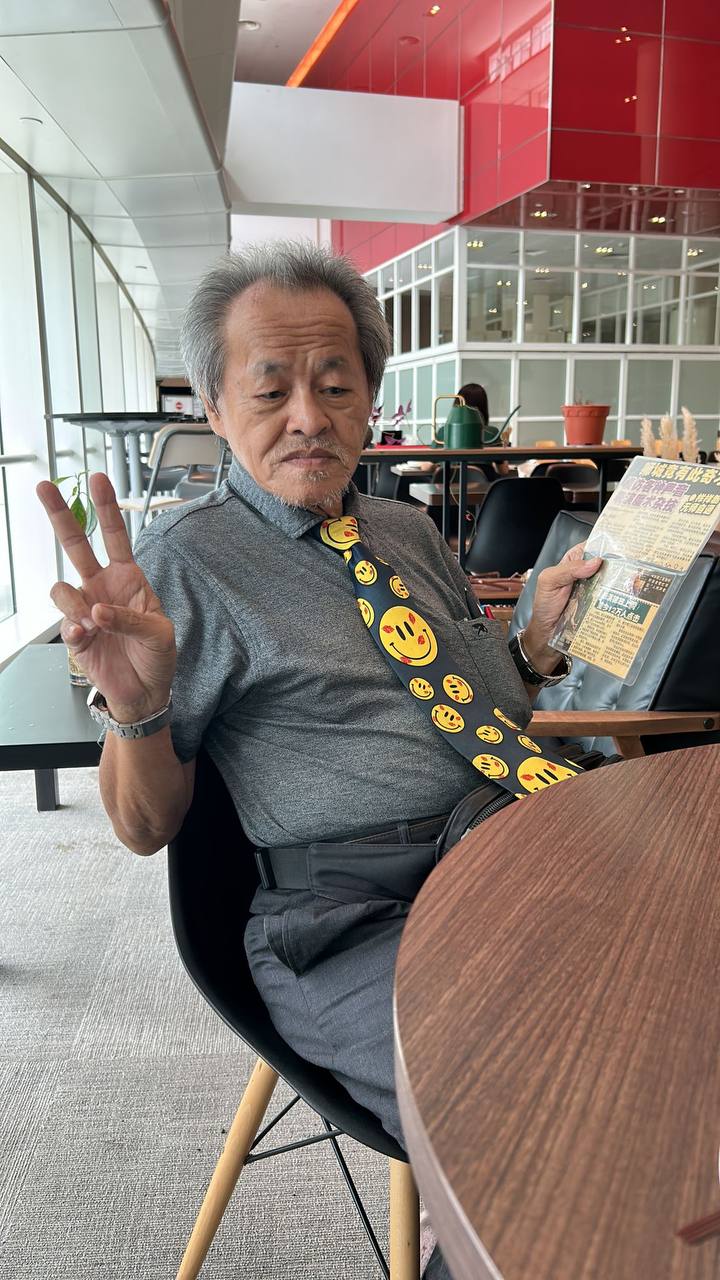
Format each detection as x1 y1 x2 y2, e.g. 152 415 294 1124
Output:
465 476 565 577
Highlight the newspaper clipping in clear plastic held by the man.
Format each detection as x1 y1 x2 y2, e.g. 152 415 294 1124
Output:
551 458 720 684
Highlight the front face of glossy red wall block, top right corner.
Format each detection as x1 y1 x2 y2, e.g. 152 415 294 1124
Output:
551 0 720 188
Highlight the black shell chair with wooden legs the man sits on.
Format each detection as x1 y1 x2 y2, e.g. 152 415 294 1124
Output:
168 751 419 1280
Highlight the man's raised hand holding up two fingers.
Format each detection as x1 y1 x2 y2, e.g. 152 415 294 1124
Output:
37 472 176 723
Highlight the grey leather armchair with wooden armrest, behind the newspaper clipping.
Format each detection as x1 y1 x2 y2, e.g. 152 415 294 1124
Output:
510 511 720 757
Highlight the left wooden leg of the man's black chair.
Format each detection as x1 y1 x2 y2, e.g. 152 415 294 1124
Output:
177 1057 278 1280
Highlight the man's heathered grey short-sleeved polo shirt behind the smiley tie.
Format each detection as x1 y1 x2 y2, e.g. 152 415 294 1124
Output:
136 461 530 845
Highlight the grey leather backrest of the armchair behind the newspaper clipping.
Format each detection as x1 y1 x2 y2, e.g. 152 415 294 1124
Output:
510 511 720 755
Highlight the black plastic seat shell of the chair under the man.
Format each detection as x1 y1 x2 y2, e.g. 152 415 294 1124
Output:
168 751 405 1160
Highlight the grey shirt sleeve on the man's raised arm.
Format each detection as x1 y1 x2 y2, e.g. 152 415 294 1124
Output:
135 526 249 763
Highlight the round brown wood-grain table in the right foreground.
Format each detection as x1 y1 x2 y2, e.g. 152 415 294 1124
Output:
396 745 720 1280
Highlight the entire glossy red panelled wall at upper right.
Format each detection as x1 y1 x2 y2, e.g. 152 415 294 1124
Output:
310 0 720 270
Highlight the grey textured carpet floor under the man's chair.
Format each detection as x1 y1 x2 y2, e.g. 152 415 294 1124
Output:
0 769 387 1280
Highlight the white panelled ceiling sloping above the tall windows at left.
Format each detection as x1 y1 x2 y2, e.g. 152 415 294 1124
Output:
0 0 238 375
